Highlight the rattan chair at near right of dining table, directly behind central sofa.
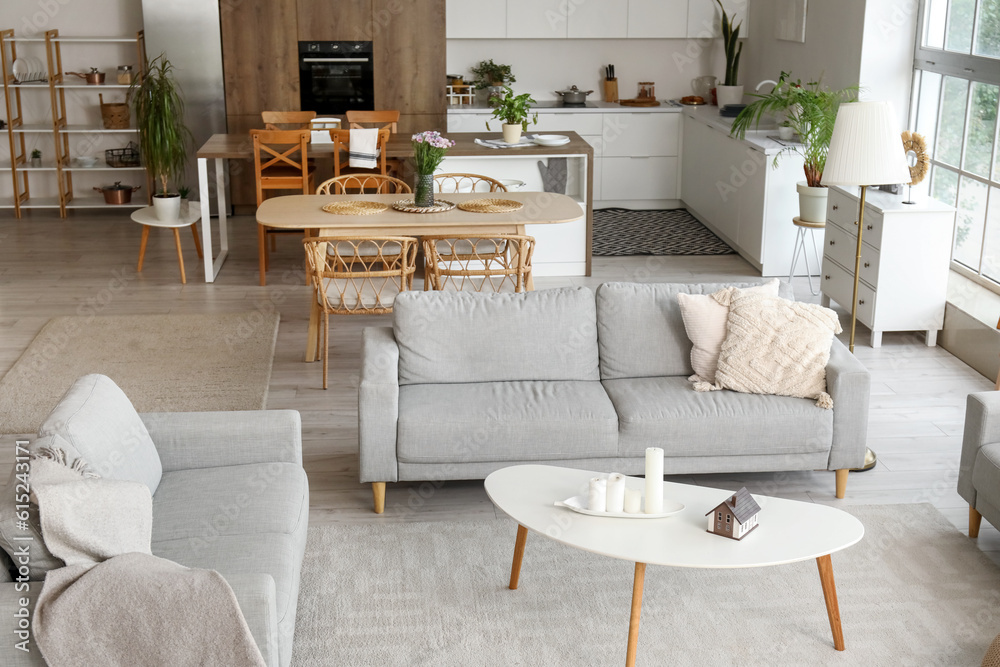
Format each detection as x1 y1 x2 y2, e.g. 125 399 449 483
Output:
423 234 535 292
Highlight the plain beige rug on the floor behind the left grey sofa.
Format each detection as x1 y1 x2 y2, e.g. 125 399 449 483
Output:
0 311 279 434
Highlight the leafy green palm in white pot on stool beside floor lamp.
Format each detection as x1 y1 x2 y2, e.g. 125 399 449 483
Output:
730 72 858 222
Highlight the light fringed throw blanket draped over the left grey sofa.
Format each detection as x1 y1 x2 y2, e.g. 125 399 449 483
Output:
31 450 264 667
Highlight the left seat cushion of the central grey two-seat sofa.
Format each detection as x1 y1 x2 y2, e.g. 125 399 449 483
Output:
396 381 618 463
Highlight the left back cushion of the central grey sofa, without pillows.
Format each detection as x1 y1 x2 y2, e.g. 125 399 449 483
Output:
392 287 600 385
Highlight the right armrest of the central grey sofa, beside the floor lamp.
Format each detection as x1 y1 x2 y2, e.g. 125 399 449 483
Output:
826 338 872 470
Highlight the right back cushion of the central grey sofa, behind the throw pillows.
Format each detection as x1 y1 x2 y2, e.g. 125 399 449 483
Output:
597 280 794 380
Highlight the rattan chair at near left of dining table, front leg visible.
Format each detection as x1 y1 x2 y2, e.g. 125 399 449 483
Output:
302 236 417 389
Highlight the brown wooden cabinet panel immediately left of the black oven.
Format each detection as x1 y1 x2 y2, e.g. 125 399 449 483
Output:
220 0 299 115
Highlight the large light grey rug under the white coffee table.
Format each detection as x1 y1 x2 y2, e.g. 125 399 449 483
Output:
292 504 1000 667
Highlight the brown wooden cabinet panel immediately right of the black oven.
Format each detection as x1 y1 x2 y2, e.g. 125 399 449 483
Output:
372 0 447 115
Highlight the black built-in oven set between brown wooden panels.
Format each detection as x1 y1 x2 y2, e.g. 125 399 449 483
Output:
299 42 375 116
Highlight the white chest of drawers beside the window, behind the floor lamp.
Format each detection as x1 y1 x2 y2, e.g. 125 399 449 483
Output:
822 188 955 347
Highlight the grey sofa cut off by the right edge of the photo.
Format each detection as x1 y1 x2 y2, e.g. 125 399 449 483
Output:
958 391 1000 537
